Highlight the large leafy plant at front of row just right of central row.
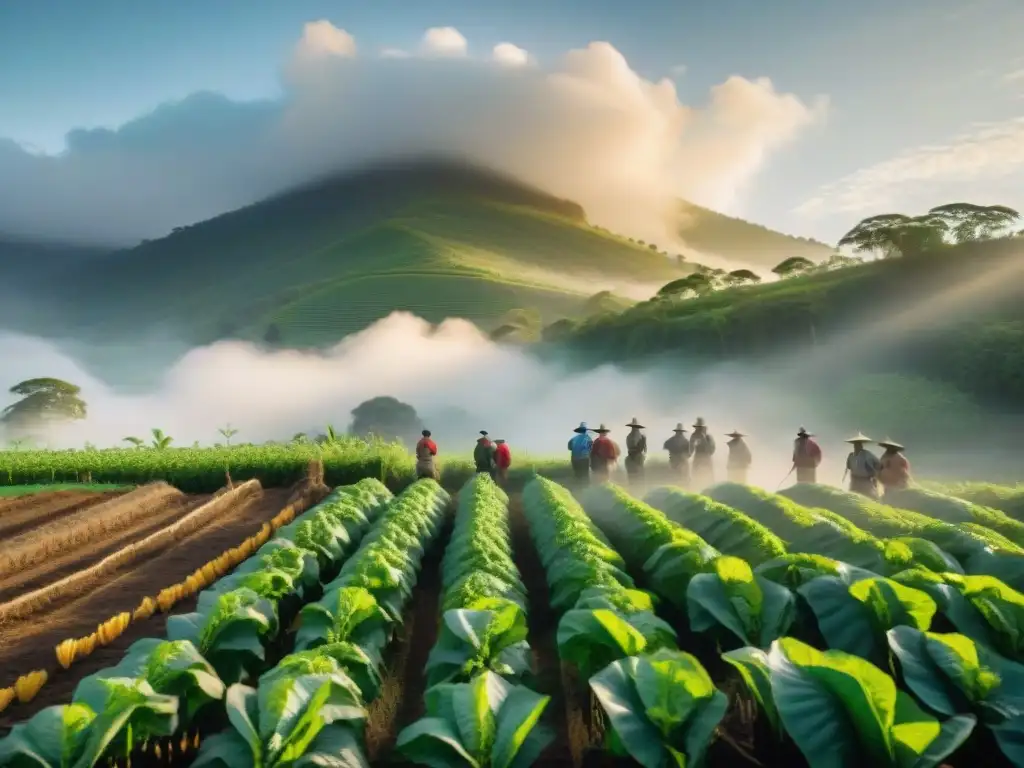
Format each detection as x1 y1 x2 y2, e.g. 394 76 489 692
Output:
590 650 728 768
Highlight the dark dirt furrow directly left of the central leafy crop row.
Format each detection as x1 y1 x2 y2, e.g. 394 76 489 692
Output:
367 511 453 766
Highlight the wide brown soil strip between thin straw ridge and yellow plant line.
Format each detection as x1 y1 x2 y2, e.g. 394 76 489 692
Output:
0 488 290 730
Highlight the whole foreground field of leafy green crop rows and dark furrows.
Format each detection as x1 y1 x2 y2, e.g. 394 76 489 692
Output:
0 468 1024 768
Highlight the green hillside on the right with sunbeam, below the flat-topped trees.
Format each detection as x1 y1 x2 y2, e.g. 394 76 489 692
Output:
559 239 1024 409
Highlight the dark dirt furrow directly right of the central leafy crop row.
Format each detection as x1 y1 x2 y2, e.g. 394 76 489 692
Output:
509 495 583 766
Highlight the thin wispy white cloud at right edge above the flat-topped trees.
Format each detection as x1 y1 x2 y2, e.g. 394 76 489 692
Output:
796 118 1024 217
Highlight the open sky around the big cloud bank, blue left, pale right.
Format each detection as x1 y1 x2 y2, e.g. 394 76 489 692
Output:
0 0 1024 241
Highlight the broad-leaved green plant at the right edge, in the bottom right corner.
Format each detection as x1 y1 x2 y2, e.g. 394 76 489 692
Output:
889 627 1024 765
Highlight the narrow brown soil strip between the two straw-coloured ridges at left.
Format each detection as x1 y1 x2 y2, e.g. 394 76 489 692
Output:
0 496 211 602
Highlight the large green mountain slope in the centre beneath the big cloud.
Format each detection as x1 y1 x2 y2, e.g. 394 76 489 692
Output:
48 164 683 346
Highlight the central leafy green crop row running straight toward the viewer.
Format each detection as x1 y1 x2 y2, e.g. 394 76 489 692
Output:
397 474 554 768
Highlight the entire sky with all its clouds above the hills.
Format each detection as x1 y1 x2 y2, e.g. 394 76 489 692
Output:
0 0 1024 242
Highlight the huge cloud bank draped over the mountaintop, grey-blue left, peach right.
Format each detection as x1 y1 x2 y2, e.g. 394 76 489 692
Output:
0 23 823 246
